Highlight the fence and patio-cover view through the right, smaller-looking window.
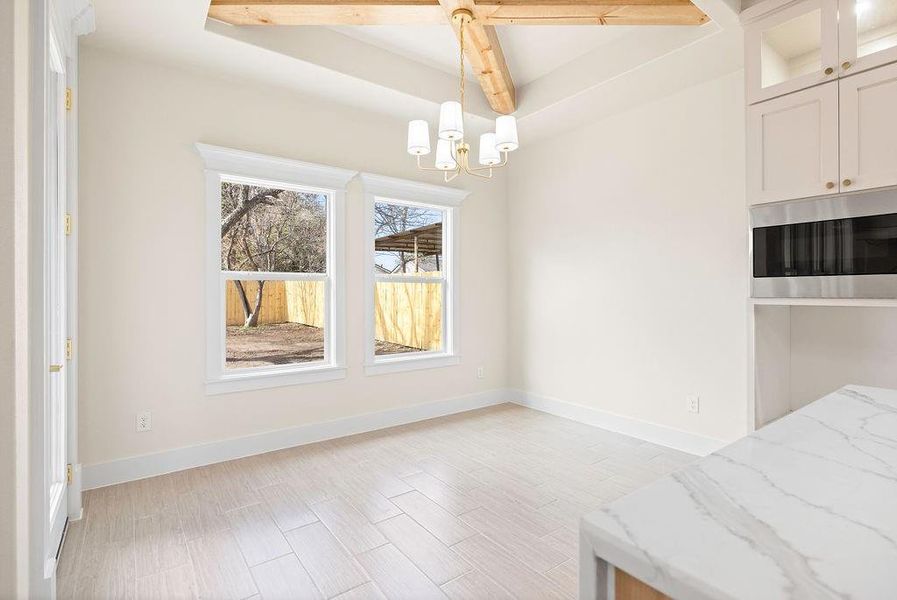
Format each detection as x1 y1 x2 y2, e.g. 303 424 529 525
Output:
374 200 446 356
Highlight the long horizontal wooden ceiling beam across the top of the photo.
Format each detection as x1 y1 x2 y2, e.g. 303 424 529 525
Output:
209 0 709 25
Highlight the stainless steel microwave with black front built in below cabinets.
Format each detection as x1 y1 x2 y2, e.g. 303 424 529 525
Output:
750 189 897 298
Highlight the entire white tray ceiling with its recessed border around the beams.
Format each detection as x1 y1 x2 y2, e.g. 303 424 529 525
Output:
82 0 742 140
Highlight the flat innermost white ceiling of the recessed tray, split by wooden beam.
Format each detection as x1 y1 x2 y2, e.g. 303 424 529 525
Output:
331 25 632 87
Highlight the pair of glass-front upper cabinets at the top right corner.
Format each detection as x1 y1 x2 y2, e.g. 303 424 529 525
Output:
742 0 897 104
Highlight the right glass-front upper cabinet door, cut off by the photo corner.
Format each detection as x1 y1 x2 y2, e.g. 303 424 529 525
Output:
838 0 897 76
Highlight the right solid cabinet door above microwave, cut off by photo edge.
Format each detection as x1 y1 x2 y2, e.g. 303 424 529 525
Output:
840 64 897 191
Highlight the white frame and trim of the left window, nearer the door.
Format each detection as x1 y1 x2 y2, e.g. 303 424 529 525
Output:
196 143 357 395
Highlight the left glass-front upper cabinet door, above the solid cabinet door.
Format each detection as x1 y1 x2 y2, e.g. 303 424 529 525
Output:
744 0 840 104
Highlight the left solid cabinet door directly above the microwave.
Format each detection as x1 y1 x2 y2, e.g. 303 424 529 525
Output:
747 81 839 204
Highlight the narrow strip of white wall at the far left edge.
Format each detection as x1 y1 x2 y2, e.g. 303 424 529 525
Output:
0 0 29 598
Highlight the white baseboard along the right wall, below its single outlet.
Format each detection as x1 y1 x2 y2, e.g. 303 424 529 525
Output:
507 390 728 456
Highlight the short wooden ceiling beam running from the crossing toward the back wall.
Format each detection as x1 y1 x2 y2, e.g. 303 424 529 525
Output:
439 0 517 115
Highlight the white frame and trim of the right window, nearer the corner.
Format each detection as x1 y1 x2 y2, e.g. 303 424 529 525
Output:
361 173 470 375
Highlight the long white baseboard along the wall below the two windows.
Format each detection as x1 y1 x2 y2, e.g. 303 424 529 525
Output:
81 389 510 490
